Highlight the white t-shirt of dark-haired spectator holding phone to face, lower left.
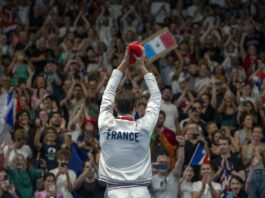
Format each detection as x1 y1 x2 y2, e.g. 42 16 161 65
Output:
50 168 76 198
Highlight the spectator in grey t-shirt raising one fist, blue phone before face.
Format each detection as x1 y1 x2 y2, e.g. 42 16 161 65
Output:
150 136 185 198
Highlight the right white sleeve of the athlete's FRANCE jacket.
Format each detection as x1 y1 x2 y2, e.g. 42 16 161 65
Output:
140 73 161 134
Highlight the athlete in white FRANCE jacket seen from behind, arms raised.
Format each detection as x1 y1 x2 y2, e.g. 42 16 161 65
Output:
98 44 161 198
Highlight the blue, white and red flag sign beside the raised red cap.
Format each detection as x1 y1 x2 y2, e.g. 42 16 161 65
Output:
144 28 177 60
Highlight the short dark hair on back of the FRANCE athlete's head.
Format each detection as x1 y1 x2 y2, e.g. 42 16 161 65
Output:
115 89 137 114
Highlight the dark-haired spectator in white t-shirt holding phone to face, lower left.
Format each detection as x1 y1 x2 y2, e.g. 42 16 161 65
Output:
50 149 76 198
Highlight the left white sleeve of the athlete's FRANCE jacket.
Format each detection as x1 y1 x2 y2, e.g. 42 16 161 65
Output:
98 69 123 131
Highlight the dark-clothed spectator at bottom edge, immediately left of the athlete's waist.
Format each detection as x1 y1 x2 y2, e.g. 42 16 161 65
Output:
74 159 105 198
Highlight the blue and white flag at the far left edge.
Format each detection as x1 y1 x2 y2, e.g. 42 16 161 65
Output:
0 89 15 143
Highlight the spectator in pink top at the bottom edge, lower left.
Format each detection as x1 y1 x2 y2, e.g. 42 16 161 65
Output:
34 173 63 198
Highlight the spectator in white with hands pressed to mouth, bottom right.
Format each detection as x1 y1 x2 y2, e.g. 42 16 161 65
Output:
192 164 221 198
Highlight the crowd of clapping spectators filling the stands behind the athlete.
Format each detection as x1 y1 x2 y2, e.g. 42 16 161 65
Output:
0 0 265 198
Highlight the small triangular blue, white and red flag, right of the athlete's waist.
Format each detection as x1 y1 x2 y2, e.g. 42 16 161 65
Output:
190 144 210 165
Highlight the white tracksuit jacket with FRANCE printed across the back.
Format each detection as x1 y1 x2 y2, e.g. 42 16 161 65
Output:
98 70 161 186
